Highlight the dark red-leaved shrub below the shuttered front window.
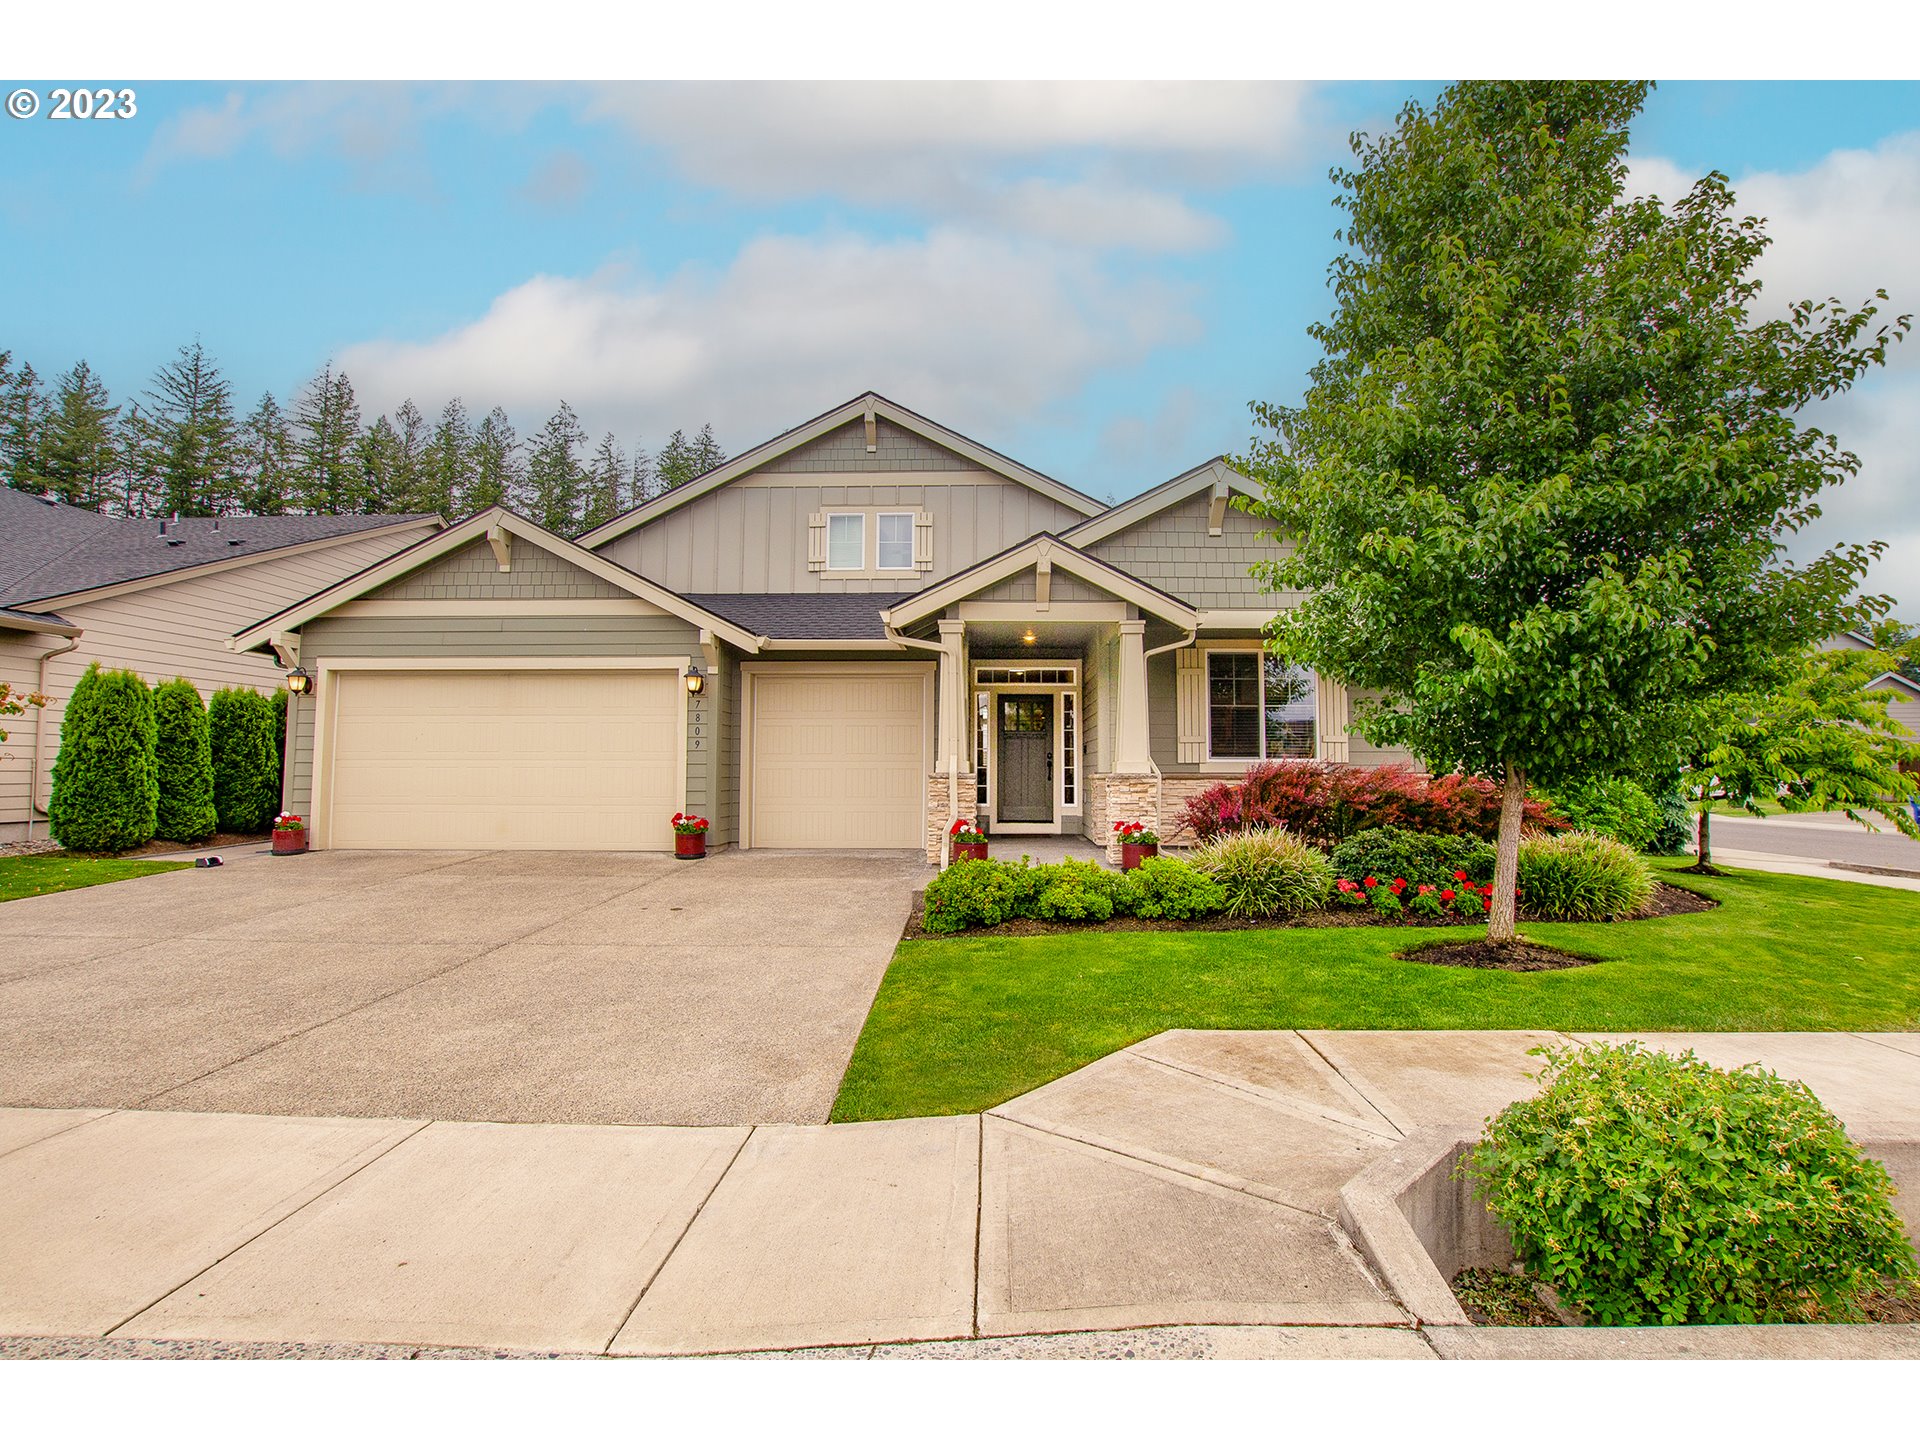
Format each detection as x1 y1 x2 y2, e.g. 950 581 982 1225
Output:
1187 760 1567 849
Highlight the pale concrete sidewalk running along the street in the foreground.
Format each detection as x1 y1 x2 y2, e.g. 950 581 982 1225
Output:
0 1031 1920 1357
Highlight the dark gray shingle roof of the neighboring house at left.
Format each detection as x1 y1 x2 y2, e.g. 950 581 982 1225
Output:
0 488 438 609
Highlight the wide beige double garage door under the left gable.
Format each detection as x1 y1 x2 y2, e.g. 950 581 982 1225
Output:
323 670 685 851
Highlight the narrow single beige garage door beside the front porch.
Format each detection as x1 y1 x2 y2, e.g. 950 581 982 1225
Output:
751 666 929 851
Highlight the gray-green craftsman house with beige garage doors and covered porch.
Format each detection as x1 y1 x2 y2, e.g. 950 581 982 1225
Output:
232 394 1409 862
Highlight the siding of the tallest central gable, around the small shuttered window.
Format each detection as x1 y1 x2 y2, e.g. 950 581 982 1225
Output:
599 422 1085 595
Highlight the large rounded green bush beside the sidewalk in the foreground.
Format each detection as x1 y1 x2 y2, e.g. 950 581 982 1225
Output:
1459 1043 1914 1325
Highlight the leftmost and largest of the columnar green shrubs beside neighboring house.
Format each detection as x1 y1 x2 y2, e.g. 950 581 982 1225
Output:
46 660 159 851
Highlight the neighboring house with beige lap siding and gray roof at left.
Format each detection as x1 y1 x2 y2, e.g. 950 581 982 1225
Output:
0 488 442 841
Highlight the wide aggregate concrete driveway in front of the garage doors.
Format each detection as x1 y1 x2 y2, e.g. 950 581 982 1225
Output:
0 851 925 1125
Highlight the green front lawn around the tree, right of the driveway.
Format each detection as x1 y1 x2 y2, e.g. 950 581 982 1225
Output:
833 860 1920 1121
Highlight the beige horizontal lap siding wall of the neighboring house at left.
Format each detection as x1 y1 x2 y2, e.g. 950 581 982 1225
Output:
0 522 436 841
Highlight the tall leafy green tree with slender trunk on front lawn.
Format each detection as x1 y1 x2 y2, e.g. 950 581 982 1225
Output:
1244 81 1908 939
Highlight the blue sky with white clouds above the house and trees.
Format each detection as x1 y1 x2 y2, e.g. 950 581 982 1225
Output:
11 81 1920 614
